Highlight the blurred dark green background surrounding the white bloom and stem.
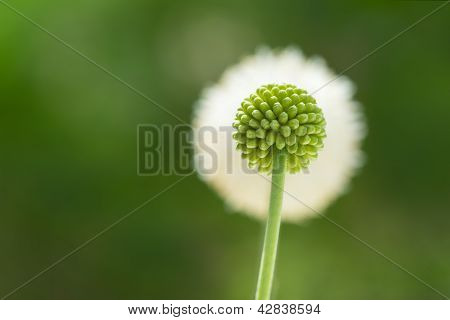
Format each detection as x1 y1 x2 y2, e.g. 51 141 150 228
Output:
0 0 450 299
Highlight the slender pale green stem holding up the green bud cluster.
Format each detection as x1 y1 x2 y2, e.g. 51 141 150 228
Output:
255 148 287 300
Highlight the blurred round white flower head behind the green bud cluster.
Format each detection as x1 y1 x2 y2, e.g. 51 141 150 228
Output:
193 47 365 221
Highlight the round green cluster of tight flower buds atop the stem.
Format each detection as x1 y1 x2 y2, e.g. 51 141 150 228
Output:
232 84 326 173
